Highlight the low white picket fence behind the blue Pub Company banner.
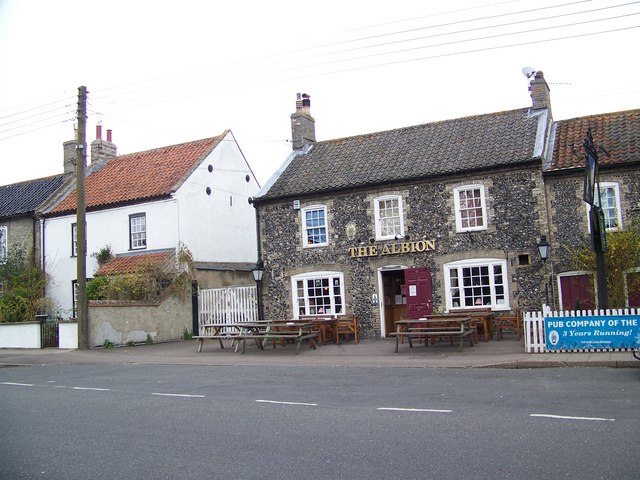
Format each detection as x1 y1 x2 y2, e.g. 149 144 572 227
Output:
524 305 640 353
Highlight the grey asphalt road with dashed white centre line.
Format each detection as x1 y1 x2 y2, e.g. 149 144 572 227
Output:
0 365 640 480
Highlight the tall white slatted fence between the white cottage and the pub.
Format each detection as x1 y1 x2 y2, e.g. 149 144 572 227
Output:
198 287 258 334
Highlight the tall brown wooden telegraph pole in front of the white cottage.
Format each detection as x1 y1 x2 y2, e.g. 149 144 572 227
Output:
76 87 89 350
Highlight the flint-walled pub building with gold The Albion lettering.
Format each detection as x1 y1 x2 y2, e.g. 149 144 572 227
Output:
251 72 640 337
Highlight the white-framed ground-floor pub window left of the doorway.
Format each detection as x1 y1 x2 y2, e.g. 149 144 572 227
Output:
291 272 344 318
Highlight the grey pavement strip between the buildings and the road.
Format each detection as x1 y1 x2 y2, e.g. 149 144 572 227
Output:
0 337 640 368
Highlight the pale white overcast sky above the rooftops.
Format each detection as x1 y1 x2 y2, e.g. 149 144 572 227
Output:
0 0 640 185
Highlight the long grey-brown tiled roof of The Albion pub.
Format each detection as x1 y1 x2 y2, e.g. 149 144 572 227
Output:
260 108 538 199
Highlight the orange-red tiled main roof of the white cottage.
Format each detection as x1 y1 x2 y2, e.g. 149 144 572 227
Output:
52 132 226 214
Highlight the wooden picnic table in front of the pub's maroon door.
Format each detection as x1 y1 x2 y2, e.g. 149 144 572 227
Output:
391 316 475 353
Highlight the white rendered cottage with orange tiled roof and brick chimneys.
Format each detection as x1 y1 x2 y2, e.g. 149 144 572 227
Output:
42 128 260 317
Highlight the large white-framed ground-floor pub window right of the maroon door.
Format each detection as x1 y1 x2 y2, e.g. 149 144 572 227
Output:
444 258 509 310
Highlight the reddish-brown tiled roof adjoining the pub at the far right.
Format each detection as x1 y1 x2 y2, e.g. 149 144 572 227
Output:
551 109 640 170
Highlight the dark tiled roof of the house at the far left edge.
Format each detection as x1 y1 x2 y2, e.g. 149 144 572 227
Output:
0 174 64 218
